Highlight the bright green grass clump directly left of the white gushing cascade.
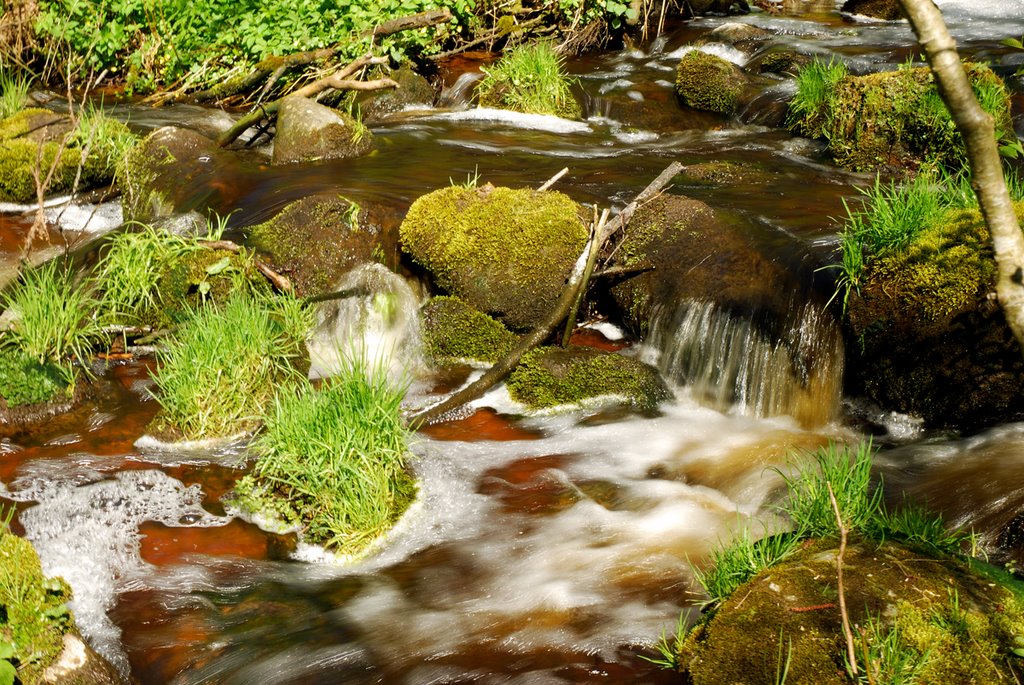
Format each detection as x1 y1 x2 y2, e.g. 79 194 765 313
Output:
154 294 311 439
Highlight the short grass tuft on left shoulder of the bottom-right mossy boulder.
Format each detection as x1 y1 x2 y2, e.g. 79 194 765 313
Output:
693 528 800 605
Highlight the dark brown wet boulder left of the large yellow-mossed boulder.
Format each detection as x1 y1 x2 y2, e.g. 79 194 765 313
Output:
248 195 382 297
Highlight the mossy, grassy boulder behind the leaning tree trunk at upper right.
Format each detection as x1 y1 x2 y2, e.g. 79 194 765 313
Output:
791 63 1013 171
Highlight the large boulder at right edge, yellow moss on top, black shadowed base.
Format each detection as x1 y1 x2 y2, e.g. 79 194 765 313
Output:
847 204 1024 429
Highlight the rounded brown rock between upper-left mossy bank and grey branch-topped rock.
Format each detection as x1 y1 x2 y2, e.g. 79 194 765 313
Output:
118 126 232 223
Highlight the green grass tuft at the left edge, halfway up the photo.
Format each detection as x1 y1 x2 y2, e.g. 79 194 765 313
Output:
0 260 105 385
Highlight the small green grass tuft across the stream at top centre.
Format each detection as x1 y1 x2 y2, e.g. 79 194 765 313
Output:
476 42 581 119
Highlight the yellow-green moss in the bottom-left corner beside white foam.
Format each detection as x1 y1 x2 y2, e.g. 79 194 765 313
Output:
0 530 74 685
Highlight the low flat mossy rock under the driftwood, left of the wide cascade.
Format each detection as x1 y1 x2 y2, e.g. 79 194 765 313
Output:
506 347 672 412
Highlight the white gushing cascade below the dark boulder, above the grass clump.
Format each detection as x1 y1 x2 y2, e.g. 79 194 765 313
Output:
306 263 420 378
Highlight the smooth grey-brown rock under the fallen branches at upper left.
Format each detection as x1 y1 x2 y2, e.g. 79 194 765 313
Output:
273 96 374 164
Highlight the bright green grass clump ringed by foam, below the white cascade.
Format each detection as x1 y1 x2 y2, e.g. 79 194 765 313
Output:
234 355 416 556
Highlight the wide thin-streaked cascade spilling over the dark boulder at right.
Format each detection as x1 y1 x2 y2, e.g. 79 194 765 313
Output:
646 300 844 427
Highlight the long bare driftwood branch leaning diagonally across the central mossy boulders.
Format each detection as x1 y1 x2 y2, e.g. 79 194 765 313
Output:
409 162 683 426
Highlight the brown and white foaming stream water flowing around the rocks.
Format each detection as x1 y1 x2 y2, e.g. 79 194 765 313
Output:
0 0 1024 684
